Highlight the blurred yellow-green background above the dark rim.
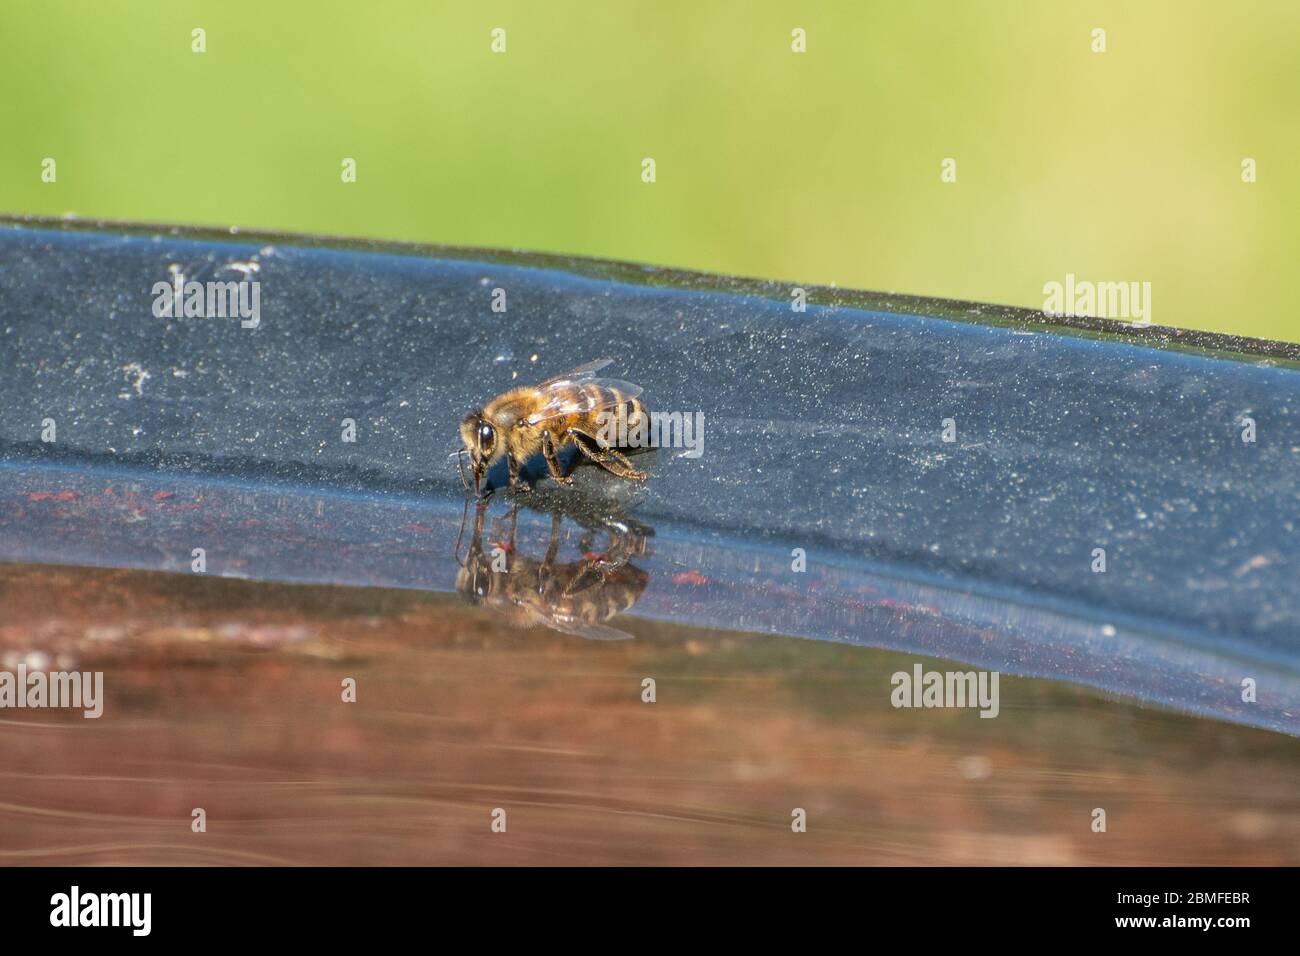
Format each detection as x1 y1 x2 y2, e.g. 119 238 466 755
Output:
0 0 1300 341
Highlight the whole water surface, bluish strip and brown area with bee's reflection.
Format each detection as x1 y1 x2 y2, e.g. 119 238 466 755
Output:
0 470 1300 866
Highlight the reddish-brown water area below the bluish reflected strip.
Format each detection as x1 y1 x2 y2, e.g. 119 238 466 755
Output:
0 564 1300 865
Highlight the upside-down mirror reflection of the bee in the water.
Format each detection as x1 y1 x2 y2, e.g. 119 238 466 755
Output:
456 502 654 640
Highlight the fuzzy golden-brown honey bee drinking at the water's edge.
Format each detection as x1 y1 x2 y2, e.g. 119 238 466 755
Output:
455 359 649 494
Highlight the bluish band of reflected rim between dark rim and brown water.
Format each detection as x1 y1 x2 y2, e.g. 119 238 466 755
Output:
0 463 1300 736
